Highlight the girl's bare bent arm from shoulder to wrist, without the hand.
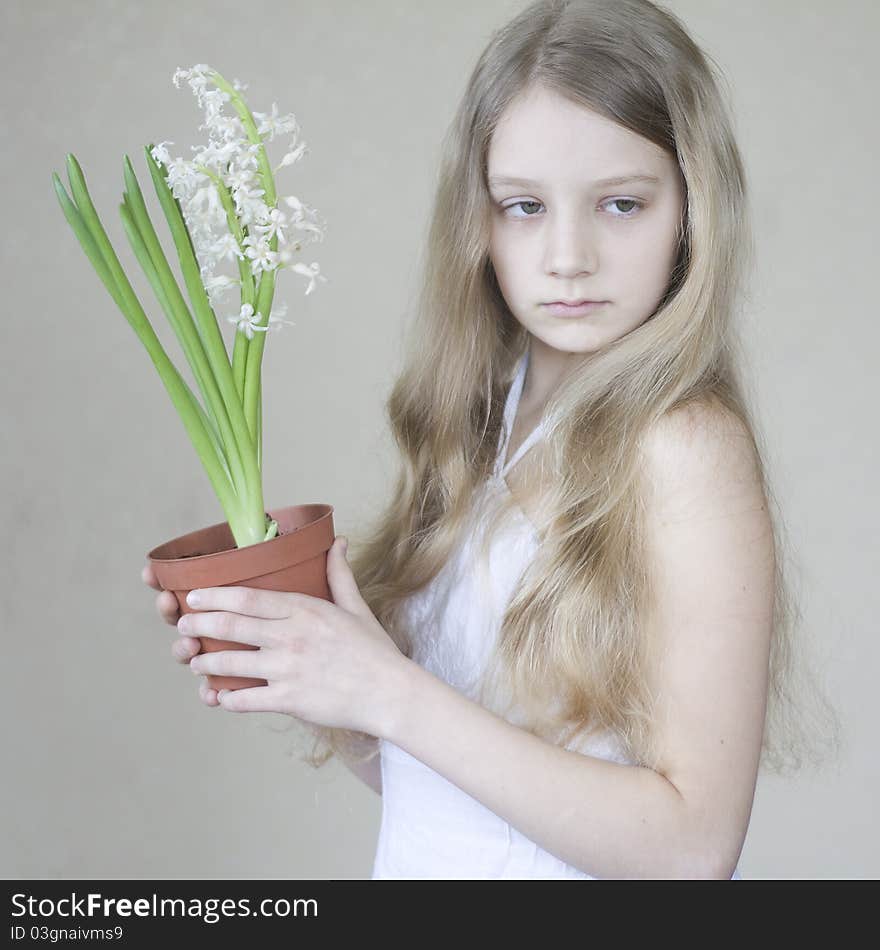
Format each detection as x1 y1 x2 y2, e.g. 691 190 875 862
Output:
380 410 774 879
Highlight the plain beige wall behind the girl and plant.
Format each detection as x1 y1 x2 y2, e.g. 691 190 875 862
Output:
0 0 880 879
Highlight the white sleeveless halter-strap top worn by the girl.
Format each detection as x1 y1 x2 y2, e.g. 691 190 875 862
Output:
372 350 741 880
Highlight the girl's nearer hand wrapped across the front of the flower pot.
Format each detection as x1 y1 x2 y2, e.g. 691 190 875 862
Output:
178 538 410 736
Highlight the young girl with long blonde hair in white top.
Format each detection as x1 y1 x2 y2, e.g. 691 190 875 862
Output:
145 0 833 879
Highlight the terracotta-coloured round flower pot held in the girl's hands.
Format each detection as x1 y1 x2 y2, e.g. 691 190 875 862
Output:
147 505 336 690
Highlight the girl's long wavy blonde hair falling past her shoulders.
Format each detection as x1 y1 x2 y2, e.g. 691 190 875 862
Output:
294 0 838 772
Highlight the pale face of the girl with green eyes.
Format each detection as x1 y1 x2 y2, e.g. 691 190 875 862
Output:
488 86 684 359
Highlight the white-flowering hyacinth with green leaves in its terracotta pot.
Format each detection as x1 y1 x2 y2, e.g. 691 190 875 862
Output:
52 64 335 689
